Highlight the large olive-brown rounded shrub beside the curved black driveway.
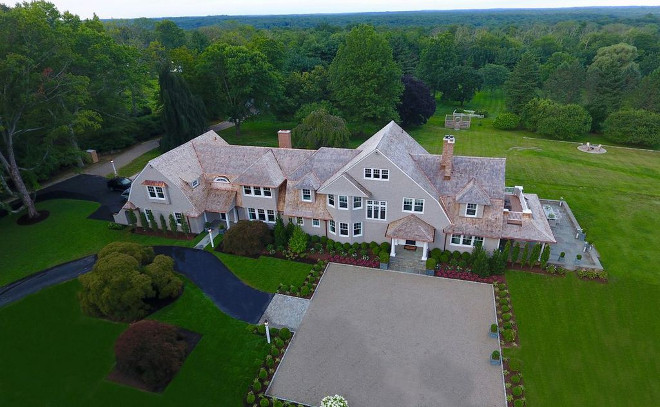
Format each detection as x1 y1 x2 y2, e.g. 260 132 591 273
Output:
78 243 182 321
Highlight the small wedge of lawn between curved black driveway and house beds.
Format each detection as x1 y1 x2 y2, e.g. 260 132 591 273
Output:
212 251 312 293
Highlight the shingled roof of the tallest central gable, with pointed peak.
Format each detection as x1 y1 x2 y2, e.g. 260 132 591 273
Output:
321 121 438 198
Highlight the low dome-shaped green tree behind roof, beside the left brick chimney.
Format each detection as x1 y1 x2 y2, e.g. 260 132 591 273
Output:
292 109 351 150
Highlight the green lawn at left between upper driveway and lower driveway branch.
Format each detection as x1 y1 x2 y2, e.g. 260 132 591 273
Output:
0 199 192 286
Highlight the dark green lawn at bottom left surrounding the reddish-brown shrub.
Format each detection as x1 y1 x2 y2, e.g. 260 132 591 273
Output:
0 281 267 406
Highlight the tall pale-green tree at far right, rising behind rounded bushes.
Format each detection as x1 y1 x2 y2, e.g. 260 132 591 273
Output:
587 43 640 131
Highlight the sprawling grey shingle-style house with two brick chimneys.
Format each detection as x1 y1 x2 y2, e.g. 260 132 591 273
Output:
115 122 555 259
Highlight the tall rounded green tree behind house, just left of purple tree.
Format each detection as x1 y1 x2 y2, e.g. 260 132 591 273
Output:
328 25 403 123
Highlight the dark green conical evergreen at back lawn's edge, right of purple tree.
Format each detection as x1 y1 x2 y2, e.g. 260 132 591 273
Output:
504 52 539 114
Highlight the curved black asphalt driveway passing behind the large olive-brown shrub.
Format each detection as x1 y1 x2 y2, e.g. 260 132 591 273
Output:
0 246 273 324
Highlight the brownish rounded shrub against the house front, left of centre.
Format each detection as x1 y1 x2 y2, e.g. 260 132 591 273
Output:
222 220 273 256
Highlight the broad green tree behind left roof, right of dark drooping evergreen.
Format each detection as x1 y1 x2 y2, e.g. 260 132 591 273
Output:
196 42 281 135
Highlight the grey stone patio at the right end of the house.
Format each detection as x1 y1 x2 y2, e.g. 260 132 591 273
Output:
540 199 603 270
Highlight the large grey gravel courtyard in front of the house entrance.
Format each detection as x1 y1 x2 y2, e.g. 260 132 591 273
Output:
268 264 505 407
